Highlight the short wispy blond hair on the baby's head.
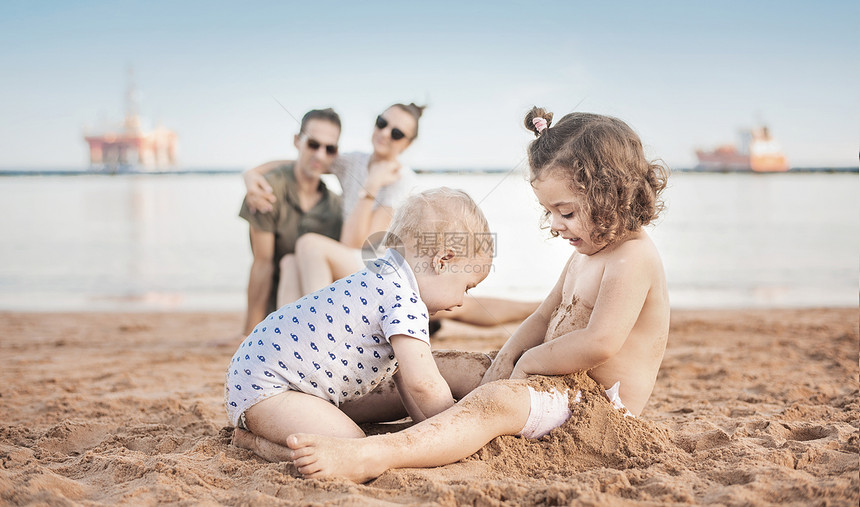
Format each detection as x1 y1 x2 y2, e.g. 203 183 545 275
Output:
383 187 495 256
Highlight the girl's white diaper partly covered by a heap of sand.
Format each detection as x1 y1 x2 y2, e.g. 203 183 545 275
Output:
518 382 634 438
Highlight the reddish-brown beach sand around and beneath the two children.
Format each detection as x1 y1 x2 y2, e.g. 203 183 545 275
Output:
0 308 860 507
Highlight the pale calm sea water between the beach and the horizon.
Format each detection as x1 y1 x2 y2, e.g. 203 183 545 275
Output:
0 170 860 311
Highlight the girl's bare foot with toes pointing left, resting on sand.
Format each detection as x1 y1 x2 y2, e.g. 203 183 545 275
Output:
287 433 387 483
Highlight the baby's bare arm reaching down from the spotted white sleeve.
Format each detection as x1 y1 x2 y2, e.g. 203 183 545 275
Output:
390 334 454 422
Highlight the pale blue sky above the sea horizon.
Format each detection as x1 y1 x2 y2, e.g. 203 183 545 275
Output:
0 0 860 169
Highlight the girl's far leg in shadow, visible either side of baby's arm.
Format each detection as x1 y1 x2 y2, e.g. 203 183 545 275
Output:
341 350 491 423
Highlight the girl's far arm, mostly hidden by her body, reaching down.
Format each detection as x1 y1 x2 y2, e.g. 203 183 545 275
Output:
481 254 575 384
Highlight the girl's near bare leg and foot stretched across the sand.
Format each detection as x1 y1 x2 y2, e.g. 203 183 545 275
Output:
287 380 530 482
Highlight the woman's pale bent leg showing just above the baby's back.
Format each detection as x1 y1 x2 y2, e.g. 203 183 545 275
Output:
296 232 364 296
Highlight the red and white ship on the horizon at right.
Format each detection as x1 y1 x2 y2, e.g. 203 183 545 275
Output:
696 126 788 173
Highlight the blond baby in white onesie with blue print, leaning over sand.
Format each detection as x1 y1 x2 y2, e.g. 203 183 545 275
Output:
225 188 493 447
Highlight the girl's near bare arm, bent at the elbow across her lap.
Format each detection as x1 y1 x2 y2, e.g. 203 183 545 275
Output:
511 248 651 378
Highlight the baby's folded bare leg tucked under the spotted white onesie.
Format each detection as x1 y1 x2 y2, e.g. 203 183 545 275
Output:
233 391 364 461
